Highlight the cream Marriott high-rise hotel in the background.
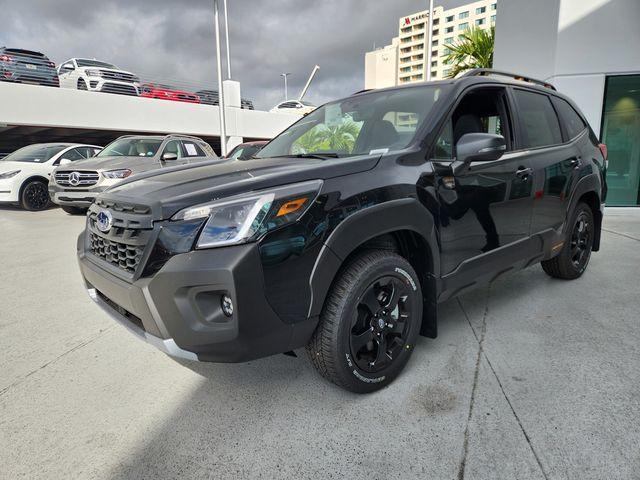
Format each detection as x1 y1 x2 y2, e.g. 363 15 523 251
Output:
365 0 497 88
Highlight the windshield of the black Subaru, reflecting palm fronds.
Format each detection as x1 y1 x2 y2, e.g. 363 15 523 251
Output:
256 85 445 158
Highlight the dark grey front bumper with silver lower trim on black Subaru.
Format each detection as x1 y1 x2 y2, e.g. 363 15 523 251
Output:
78 235 317 362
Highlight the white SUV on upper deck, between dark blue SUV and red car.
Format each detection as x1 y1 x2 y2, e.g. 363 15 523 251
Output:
58 58 140 96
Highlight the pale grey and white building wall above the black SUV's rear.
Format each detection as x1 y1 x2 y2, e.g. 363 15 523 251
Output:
494 0 640 135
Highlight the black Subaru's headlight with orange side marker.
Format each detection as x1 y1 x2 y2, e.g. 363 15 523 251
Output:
171 180 322 248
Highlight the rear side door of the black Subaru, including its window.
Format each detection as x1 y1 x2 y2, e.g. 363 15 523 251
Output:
512 87 580 234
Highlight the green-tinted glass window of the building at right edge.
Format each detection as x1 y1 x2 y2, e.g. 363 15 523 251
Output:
602 75 640 205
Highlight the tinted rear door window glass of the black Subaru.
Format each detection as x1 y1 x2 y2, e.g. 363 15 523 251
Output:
513 90 562 148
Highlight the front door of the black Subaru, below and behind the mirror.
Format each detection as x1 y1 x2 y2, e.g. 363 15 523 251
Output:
434 87 533 278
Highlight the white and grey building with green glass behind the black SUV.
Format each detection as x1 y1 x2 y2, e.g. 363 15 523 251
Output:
494 0 640 206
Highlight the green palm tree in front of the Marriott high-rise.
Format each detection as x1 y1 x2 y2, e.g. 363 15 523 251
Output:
445 27 495 78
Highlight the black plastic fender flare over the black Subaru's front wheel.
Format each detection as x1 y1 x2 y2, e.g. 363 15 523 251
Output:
309 198 440 321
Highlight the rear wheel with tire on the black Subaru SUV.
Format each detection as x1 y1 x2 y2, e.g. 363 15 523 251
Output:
542 203 595 280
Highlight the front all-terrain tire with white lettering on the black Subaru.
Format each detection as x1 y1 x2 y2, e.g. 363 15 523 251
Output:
307 250 422 393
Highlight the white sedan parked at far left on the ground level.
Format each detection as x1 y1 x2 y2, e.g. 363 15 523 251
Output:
0 143 102 210
